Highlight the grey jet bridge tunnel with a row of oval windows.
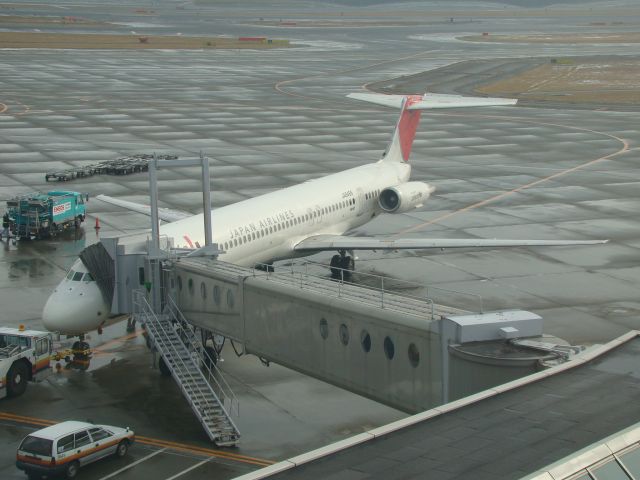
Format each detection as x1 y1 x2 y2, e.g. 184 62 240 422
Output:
163 257 571 412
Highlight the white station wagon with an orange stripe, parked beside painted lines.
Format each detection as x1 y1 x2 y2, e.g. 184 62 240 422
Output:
16 421 135 479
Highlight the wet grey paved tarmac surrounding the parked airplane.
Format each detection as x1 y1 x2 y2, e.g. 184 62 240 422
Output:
0 2 640 479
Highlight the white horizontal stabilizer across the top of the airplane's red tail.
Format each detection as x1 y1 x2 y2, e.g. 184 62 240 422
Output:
347 93 518 110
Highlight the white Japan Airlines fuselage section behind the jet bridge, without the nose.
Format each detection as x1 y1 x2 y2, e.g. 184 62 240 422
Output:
160 161 411 266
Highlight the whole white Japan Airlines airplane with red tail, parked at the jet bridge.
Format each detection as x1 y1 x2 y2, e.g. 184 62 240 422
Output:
42 93 606 338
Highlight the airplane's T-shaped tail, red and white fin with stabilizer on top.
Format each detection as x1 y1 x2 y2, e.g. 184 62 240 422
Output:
347 93 517 162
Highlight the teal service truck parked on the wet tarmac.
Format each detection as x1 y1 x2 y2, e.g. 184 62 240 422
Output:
7 190 89 239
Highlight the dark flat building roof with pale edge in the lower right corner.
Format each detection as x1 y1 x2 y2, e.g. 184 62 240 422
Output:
240 331 640 480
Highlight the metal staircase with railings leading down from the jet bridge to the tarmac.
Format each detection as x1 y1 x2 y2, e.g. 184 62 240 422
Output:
134 292 240 447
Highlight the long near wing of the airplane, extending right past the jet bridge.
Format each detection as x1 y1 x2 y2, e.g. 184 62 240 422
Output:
294 235 609 252
